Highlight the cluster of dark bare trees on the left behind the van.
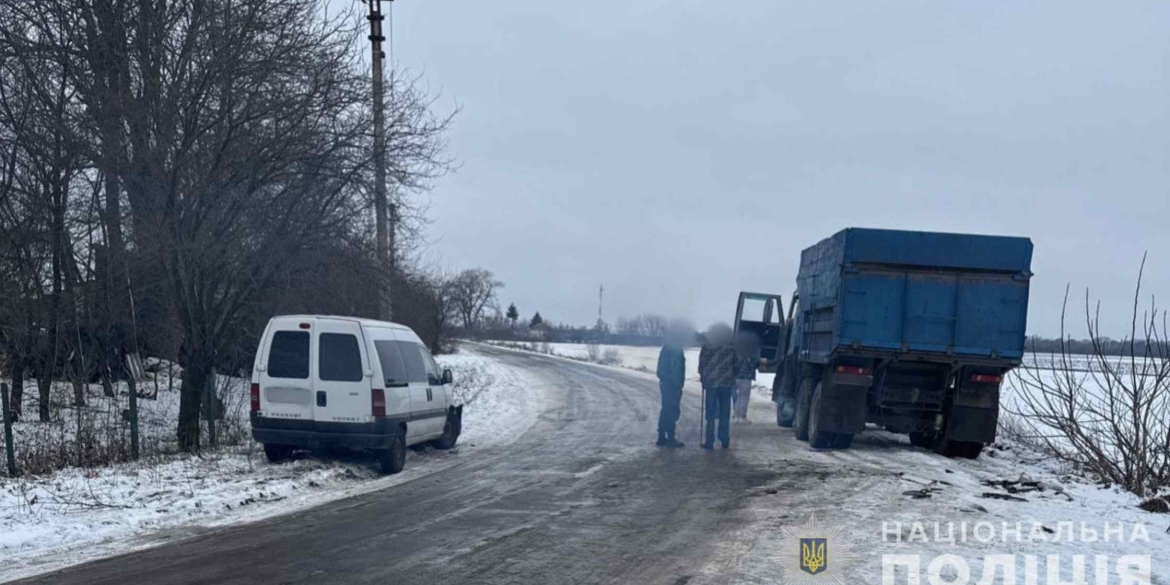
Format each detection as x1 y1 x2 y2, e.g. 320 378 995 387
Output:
0 0 452 450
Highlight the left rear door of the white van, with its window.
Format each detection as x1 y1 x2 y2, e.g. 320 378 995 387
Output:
257 319 314 421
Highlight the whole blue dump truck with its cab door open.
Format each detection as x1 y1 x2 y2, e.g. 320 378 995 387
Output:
736 228 1032 459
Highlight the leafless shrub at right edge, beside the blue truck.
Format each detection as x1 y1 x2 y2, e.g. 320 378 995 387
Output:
1009 257 1170 496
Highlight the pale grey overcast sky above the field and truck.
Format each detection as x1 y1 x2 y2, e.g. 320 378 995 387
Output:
360 0 1170 335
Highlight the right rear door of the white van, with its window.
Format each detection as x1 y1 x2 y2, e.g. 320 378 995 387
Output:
314 319 373 422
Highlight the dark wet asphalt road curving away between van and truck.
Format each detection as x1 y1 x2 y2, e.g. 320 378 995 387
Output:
19 349 842 585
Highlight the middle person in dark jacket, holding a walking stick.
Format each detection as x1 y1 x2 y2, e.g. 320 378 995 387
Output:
698 323 738 449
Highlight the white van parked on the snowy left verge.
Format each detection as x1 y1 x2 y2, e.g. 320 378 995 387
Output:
252 315 463 473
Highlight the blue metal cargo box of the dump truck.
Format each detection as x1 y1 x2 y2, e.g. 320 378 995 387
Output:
797 228 1032 363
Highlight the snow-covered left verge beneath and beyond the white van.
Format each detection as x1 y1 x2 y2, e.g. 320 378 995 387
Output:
0 343 541 581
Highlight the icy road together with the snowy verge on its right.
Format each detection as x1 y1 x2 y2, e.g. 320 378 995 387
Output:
11 347 1170 585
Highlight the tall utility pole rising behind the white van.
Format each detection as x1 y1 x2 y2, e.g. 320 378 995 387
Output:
366 0 394 321
